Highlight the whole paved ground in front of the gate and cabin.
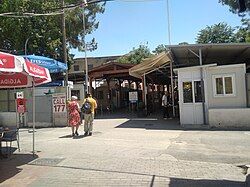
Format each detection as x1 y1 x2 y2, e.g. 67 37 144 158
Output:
0 118 250 187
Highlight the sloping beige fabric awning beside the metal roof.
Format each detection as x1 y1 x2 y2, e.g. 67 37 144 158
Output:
129 52 172 78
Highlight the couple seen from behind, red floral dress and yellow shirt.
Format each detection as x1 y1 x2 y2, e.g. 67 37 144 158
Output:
68 93 97 136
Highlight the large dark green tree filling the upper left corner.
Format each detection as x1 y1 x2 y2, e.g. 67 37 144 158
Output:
0 0 104 65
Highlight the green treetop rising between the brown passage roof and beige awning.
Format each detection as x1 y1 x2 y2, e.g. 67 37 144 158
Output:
117 45 152 64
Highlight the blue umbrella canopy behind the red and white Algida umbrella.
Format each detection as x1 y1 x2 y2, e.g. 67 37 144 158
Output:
23 55 68 73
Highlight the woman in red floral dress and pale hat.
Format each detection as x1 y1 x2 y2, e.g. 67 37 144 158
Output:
68 96 81 136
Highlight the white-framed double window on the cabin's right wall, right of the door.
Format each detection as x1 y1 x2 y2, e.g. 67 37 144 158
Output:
214 75 235 96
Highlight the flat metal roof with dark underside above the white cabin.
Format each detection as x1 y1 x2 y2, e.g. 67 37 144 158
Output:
167 43 250 67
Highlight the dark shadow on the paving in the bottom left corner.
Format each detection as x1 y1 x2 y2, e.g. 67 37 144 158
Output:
0 154 38 184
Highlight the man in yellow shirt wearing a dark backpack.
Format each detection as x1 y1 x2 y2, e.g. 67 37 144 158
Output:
82 93 97 136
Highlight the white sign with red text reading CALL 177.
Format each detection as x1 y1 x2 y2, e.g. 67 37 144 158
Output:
52 93 67 113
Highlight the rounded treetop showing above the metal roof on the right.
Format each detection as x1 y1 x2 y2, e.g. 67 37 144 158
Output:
196 23 236 43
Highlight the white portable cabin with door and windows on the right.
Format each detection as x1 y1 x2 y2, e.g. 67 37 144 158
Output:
175 64 247 127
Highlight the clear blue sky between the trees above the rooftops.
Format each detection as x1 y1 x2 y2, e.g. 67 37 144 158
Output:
71 0 241 58
